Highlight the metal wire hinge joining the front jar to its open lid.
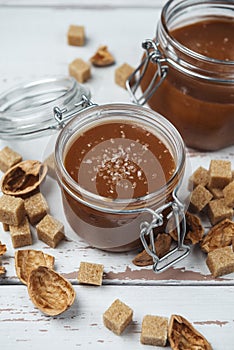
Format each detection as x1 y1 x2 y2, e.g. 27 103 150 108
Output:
53 95 97 128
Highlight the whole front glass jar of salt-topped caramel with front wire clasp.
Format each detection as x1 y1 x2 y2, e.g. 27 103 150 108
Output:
55 104 189 270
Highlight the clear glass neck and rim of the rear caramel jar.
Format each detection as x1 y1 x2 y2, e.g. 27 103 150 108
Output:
156 0 234 84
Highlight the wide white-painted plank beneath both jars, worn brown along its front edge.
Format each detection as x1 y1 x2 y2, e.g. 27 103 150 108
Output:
0 7 234 285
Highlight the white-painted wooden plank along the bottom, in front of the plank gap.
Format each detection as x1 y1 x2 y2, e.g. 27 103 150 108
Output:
0 286 234 350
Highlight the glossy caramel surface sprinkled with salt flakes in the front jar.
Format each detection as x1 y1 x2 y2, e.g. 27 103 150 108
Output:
64 122 175 199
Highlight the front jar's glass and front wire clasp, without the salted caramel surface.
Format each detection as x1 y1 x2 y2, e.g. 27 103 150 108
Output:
55 104 189 270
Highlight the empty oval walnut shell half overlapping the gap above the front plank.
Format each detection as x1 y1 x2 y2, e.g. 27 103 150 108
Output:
28 266 76 316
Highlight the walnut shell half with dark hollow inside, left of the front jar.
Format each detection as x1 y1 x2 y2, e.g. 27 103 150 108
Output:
1 160 47 197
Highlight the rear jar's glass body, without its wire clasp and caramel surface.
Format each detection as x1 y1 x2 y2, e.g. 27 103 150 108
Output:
141 0 234 150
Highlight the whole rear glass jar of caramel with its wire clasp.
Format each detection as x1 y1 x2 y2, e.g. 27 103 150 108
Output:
127 0 234 150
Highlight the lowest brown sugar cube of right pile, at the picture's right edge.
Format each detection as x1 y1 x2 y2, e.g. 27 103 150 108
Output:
206 246 234 277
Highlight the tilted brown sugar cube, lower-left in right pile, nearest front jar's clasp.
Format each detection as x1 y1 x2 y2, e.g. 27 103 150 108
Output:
190 185 213 212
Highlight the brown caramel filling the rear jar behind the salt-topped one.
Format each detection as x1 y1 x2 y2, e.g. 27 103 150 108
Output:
141 17 234 150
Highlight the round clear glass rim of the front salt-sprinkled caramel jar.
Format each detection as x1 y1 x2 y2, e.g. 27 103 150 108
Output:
55 103 186 213
